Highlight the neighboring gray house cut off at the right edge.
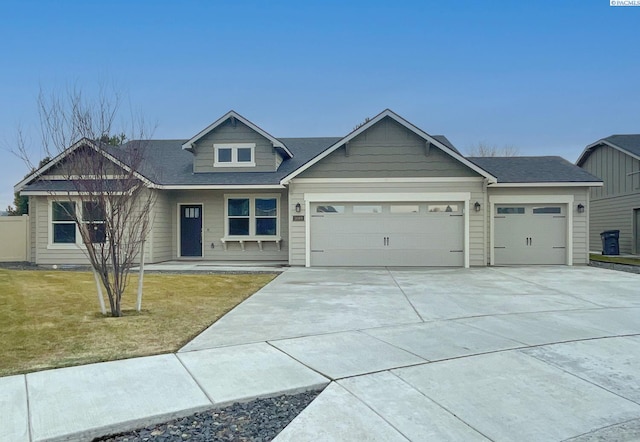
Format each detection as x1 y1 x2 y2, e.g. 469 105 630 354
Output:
576 135 640 254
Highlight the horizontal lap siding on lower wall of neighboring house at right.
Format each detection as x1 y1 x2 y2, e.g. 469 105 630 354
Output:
589 192 640 254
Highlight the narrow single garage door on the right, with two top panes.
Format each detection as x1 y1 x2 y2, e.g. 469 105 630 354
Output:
494 204 567 265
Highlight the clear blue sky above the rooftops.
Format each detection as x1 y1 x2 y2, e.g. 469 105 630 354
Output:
0 0 640 210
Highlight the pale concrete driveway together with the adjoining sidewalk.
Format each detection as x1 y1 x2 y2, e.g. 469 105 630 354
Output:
0 267 640 441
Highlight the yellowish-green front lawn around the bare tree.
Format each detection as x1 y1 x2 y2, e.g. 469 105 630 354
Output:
0 269 274 376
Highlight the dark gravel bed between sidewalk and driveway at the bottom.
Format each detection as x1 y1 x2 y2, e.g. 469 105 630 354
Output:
94 390 321 442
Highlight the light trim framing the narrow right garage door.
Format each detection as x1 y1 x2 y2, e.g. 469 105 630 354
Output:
489 195 574 266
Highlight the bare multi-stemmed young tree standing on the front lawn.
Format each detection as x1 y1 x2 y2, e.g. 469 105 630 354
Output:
18 84 155 316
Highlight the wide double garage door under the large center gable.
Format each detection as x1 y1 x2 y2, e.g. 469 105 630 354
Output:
311 202 464 267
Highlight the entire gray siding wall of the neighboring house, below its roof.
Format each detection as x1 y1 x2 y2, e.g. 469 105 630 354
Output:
582 146 640 253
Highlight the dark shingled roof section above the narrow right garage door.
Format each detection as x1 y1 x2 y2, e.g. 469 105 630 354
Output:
468 156 602 185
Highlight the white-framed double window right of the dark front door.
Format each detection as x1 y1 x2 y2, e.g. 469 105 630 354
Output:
225 195 280 238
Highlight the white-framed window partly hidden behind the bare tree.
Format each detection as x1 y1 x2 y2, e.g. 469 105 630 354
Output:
49 200 106 248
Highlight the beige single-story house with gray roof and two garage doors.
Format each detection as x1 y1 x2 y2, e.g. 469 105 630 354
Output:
16 110 602 267
